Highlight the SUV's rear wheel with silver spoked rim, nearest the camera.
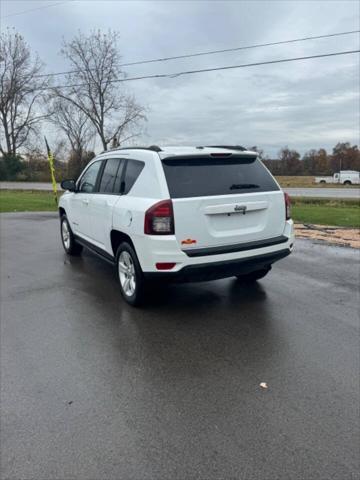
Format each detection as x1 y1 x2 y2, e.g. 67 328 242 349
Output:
116 242 146 306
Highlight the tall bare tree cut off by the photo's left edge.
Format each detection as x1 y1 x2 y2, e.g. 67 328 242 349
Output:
0 29 48 155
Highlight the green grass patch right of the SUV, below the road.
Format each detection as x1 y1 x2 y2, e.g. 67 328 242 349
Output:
291 197 360 228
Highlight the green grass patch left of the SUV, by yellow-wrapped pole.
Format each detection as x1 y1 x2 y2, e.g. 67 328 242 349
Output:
0 190 57 212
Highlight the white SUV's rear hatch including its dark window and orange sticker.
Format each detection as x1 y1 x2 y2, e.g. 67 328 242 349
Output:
162 153 285 250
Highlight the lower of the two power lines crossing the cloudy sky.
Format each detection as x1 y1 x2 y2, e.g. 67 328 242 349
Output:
36 50 360 90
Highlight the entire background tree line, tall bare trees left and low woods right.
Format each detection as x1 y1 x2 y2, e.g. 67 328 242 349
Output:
0 29 360 181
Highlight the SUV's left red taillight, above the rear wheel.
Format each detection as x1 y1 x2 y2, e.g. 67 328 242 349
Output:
144 200 174 235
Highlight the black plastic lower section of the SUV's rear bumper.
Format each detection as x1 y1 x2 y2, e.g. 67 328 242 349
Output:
144 248 291 282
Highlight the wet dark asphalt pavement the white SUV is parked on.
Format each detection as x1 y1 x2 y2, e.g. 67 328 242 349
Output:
0 213 359 480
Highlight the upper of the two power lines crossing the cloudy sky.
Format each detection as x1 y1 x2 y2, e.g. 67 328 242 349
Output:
34 30 360 77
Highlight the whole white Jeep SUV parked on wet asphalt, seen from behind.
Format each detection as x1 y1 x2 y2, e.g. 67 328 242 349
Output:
59 146 294 305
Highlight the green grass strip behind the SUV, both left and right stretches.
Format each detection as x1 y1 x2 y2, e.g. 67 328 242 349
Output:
0 190 360 228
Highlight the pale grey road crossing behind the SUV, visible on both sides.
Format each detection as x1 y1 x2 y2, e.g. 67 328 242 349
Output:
0 182 360 199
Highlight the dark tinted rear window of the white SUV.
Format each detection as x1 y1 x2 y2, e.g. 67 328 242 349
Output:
162 156 279 198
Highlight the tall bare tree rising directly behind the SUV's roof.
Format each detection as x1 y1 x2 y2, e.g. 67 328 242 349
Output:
54 30 146 150
